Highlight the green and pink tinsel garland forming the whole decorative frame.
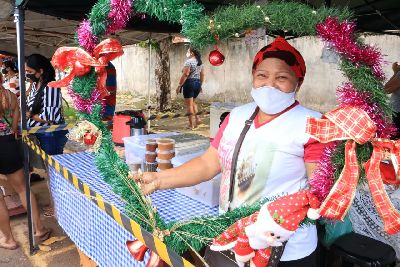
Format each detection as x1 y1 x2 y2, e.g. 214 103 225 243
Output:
50 0 393 260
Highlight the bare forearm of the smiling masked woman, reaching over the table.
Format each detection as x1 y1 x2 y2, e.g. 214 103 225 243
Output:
135 146 221 194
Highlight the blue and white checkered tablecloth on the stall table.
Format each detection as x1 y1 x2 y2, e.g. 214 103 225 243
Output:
49 153 218 267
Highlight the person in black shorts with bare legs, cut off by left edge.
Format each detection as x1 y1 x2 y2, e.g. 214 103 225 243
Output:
0 74 51 250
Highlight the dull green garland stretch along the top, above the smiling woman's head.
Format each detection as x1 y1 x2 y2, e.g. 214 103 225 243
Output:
182 1 352 47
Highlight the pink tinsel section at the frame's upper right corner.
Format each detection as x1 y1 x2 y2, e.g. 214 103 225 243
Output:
316 17 385 80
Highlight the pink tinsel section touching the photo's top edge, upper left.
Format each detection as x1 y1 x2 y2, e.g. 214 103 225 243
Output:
106 0 132 34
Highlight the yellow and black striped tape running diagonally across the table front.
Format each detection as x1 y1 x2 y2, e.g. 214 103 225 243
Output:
23 136 194 267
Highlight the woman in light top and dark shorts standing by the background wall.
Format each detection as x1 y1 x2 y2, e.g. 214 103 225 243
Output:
176 48 204 129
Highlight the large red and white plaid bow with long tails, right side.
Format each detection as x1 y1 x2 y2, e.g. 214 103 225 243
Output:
307 107 400 234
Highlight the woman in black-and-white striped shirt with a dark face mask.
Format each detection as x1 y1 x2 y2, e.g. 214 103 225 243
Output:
25 54 67 155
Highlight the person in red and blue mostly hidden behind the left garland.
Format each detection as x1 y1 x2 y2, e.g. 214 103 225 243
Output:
103 62 117 121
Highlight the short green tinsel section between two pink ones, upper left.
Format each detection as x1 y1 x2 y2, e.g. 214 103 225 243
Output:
89 0 111 37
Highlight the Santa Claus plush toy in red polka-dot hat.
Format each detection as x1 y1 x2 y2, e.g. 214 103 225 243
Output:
210 190 320 267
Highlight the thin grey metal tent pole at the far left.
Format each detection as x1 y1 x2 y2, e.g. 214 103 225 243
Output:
14 6 35 255
